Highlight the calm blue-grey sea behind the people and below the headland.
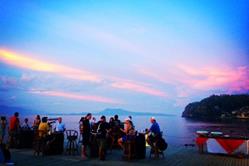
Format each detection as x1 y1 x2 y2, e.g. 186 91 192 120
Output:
21 115 249 145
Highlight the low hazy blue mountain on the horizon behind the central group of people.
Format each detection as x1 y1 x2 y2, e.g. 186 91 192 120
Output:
97 108 174 116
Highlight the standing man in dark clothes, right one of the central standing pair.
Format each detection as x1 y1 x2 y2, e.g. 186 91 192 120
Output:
97 116 110 160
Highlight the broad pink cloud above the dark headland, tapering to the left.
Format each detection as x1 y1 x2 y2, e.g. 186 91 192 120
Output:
138 64 249 97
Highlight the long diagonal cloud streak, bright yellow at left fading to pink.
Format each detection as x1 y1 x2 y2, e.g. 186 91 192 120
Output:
0 49 166 97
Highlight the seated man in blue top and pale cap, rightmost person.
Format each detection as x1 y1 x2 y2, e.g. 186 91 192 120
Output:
146 117 162 148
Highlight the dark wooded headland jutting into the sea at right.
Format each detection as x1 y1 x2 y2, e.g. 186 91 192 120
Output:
182 94 249 119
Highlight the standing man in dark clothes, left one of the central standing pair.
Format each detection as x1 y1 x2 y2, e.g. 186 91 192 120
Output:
81 113 92 159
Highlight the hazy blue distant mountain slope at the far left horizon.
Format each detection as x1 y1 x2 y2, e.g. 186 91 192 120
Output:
0 105 39 116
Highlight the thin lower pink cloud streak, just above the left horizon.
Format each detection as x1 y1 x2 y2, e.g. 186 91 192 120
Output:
29 89 121 104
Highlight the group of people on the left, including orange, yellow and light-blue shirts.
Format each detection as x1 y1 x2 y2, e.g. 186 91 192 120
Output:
0 112 66 164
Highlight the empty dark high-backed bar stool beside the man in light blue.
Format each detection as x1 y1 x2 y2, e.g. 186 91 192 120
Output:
66 130 78 155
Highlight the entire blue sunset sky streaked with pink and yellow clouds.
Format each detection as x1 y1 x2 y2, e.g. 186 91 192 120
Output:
0 0 249 115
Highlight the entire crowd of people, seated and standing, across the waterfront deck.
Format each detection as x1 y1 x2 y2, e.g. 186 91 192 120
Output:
0 112 162 162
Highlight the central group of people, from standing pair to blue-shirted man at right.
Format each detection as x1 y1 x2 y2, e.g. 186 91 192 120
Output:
79 113 162 160
